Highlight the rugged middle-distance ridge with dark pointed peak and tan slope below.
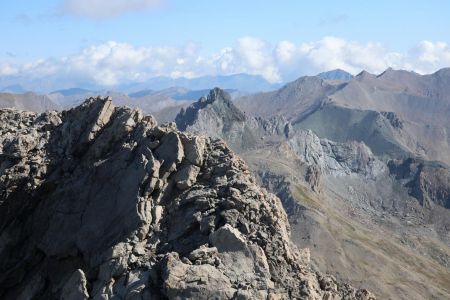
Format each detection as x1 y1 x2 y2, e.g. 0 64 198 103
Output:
176 88 450 299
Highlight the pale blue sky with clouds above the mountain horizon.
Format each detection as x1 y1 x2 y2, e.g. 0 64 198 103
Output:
0 0 450 86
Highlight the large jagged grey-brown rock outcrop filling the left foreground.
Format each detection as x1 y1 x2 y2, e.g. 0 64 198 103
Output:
0 98 374 299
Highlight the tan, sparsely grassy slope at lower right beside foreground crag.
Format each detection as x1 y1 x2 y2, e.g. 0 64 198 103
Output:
291 186 450 299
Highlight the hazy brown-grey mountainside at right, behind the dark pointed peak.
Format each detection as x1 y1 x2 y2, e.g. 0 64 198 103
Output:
236 68 450 165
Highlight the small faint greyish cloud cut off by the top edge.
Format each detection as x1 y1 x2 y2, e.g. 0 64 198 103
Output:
62 0 161 18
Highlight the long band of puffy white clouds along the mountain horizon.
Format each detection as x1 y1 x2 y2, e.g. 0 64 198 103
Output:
0 37 450 87
